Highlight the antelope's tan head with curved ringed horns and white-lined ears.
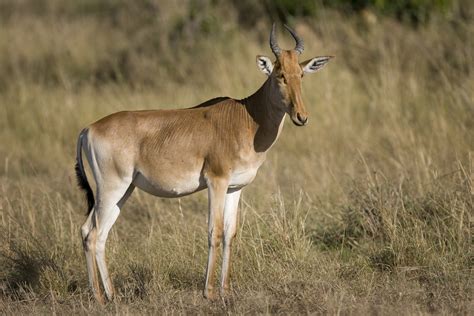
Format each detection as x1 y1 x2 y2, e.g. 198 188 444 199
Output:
257 24 333 126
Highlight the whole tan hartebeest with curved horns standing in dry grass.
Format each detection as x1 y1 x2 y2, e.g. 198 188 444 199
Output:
76 25 331 302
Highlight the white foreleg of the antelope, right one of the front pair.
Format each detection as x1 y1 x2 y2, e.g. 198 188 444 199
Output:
221 190 242 296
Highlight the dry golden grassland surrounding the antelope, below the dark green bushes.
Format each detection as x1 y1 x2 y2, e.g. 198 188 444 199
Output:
0 0 474 314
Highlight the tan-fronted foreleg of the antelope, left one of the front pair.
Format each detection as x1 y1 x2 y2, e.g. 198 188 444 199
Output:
203 177 228 300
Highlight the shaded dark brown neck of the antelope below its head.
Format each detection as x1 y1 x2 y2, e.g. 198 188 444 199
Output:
241 77 286 152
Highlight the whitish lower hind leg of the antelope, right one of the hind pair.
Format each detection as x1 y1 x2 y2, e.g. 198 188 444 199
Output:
95 184 135 300
